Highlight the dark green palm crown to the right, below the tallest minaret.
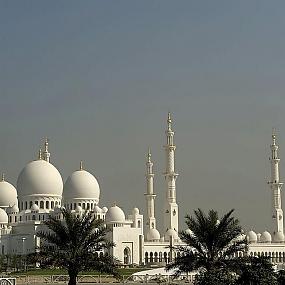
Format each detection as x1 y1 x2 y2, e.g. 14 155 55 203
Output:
166 209 247 278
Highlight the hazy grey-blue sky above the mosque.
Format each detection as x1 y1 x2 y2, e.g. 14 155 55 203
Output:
0 0 285 232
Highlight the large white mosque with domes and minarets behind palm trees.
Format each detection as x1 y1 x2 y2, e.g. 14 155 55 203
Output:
0 113 285 265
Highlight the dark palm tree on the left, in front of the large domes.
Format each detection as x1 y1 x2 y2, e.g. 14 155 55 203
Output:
37 209 119 285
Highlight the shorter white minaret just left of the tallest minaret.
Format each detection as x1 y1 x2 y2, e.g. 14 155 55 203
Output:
144 149 156 230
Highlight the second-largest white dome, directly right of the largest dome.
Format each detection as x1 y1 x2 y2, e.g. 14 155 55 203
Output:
63 170 100 203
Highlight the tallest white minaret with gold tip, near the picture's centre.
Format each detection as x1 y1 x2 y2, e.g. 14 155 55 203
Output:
164 113 178 232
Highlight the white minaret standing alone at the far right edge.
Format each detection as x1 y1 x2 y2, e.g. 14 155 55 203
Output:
268 130 283 233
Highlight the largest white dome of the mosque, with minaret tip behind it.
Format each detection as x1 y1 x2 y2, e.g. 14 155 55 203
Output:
17 160 63 197
